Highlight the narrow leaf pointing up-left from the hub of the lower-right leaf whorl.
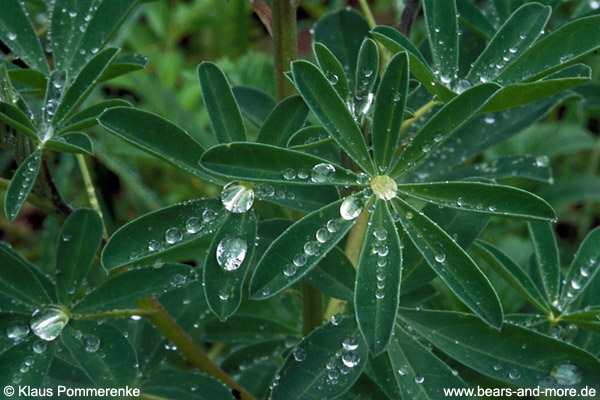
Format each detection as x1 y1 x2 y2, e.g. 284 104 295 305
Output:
471 240 550 313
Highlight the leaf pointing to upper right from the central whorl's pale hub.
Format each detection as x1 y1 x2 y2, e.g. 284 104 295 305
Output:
388 83 499 177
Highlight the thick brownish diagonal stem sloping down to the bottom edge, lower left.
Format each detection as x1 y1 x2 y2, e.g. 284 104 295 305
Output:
138 297 256 400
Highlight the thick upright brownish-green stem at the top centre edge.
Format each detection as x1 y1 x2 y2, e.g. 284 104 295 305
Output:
271 0 298 100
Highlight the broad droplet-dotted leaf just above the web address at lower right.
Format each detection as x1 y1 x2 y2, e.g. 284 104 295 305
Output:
399 308 600 387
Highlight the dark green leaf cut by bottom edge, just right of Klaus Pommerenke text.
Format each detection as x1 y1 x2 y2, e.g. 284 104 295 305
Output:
142 369 233 400
